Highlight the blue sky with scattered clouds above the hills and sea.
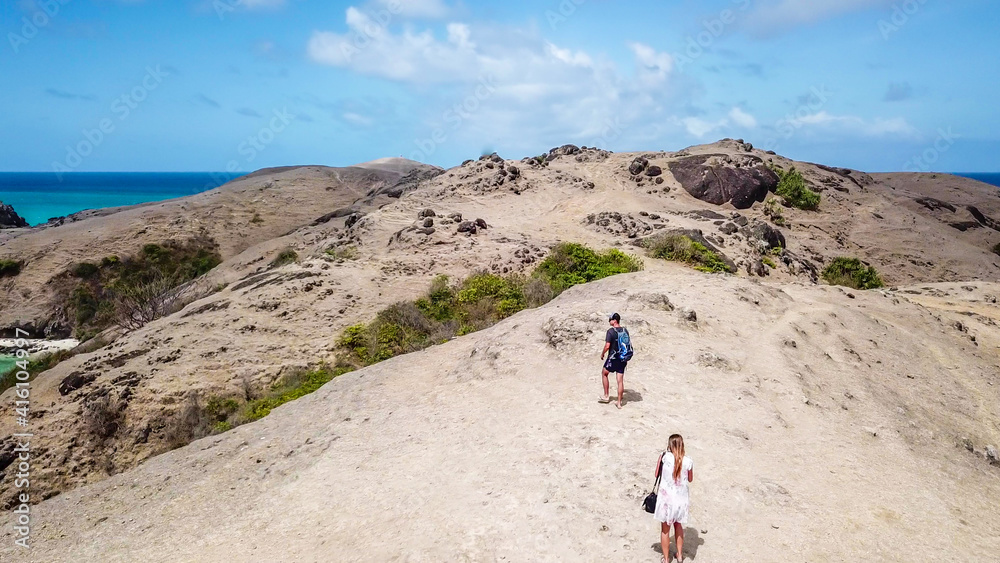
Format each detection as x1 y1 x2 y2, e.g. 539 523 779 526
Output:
0 0 1000 173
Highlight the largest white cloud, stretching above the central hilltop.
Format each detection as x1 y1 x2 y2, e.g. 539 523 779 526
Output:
308 7 686 154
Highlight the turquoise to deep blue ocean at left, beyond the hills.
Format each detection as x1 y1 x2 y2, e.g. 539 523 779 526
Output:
0 172 235 225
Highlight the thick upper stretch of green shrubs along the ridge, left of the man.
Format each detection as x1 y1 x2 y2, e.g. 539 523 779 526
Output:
339 243 643 366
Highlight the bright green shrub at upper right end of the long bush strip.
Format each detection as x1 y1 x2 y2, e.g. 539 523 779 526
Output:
533 243 643 295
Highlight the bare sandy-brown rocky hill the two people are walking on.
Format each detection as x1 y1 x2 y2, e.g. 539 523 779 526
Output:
0 140 1000 561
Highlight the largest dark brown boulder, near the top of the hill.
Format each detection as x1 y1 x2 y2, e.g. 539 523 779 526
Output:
670 154 778 209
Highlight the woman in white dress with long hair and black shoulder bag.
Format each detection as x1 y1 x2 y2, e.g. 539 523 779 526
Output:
653 434 694 563
